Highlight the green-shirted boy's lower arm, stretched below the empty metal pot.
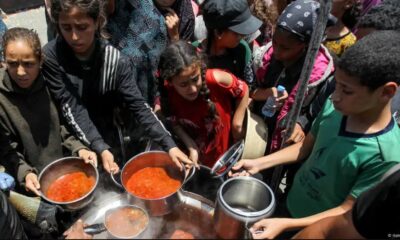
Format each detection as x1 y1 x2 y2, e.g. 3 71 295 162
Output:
252 196 356 239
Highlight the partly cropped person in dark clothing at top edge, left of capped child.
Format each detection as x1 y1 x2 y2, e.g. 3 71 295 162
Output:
154 0 195 41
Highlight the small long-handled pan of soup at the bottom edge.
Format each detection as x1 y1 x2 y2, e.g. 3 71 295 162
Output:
84 205 149 239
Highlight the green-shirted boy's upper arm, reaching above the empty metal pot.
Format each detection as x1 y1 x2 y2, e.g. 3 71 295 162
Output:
229 133 315 176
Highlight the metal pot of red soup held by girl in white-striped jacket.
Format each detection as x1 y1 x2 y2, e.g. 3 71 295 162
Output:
115 151 194 216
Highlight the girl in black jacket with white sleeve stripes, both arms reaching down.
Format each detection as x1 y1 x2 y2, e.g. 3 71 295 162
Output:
43 0 191 172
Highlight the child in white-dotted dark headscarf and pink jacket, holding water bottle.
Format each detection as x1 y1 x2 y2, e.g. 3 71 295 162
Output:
251 0 334 152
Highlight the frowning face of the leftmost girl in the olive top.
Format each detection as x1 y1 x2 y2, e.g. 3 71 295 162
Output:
5 40 40 88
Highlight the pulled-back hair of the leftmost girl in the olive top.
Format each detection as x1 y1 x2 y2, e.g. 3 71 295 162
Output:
3 27 42 60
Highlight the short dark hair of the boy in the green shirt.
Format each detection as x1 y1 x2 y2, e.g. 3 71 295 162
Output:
337 31 400 90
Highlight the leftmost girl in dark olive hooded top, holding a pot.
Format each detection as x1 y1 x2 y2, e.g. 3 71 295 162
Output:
0 28 97 196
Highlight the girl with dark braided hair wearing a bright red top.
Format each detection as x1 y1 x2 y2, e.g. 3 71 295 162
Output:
160 41 248 167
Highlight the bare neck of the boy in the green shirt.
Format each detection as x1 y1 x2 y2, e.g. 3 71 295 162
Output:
346 103 392 134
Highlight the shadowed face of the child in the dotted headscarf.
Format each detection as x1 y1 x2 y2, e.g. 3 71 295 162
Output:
272 30 306 65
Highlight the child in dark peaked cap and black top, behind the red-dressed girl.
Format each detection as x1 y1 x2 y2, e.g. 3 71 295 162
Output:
200 0 262 86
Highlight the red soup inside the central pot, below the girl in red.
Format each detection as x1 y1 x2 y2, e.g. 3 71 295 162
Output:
126 167 181 199
